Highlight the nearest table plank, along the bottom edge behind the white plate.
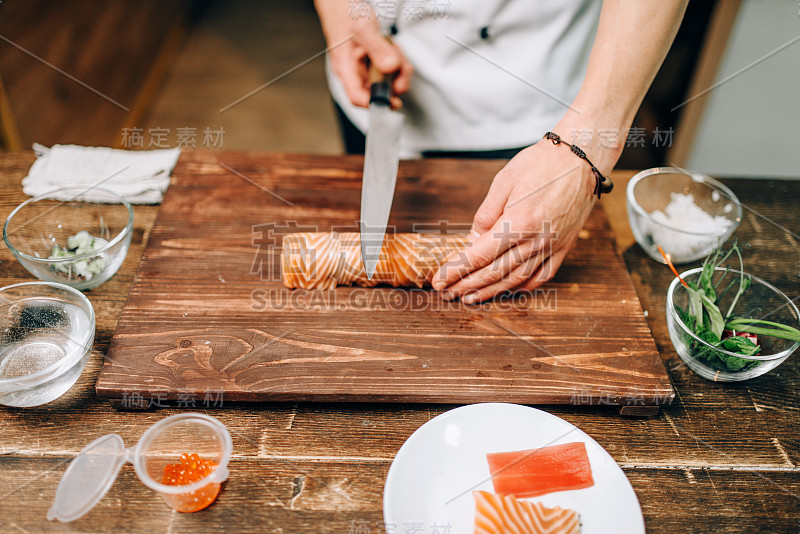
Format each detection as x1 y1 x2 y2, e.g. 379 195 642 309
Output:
0 457 800 534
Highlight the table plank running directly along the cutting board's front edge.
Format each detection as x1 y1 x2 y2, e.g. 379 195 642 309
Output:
0 402 798 470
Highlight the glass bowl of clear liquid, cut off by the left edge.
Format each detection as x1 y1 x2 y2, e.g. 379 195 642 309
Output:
0 282 95 407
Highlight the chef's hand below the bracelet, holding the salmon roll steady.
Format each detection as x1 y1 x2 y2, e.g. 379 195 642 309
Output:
432 140 595 304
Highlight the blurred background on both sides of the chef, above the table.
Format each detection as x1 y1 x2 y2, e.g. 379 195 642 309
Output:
0 0 800 178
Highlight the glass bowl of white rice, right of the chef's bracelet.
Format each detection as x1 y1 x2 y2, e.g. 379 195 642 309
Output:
626 167 742 263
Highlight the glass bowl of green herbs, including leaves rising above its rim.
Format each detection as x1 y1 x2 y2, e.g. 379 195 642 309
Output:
665 243 800 382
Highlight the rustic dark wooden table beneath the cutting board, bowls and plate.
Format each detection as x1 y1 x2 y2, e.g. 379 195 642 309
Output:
0 153 800 534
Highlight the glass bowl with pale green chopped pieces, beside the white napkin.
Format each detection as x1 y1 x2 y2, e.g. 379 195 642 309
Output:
3 187 133 289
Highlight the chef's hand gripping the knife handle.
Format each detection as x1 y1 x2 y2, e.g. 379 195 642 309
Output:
315 0 414 109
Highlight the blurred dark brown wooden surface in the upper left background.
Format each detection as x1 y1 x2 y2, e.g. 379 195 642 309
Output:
0 0 192 148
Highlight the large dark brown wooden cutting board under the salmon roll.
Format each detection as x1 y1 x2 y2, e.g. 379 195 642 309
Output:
97 152 673 412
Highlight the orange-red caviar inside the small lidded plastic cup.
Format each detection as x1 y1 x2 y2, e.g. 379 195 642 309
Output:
161 453 220 512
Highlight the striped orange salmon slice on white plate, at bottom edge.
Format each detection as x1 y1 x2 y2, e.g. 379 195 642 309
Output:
472 491 581 534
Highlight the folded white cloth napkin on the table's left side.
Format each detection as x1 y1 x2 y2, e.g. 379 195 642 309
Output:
22 143 181 204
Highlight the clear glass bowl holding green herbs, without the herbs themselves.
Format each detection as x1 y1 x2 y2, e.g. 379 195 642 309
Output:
667 267 800 382
